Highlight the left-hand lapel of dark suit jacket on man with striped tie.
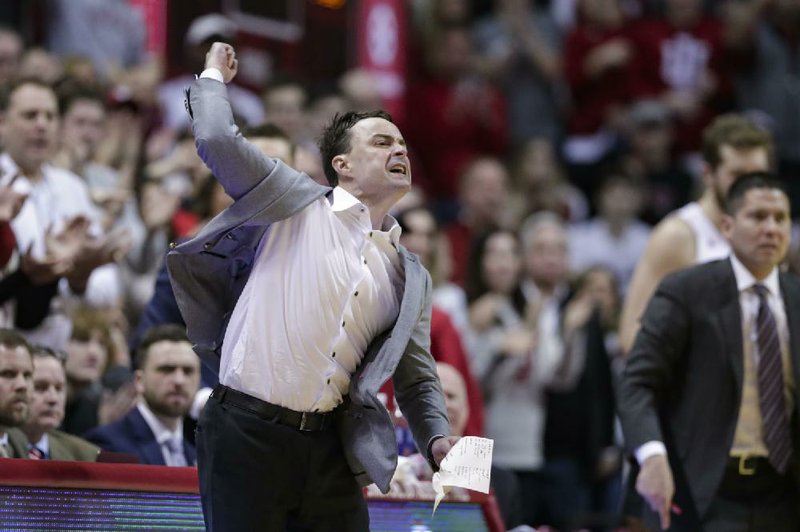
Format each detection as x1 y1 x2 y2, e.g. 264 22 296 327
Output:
711 260 744 404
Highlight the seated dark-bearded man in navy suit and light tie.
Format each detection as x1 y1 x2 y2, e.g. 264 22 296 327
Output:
85 325 200 466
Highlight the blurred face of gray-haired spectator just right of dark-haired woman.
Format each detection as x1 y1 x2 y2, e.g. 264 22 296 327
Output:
525 224 568 289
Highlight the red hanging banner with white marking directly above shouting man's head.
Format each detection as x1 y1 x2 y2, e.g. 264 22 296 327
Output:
356 0 408 120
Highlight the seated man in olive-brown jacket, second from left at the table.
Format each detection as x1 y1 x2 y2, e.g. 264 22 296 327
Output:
22 346 100 462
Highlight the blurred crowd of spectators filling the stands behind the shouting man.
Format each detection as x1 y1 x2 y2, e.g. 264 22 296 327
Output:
0 0 800 529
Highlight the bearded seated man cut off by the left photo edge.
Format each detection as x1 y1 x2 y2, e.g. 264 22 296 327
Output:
0 329 33 458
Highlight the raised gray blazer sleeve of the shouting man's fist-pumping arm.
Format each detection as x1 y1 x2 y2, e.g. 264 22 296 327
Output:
187 78 275 200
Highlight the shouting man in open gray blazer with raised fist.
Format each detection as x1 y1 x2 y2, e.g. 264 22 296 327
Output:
167 43 455 530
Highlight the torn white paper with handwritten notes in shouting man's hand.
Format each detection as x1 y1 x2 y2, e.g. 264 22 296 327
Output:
432 436 494 512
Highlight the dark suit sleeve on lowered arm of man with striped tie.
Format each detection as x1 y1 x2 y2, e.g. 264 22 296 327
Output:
617 274 690 452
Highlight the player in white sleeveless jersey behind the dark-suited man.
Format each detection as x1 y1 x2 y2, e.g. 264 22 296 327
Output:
619 114 773 353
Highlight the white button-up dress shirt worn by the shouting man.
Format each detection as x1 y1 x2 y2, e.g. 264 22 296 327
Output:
220 187 405 412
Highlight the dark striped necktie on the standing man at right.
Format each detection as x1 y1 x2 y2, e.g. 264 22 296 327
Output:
753 284 792 474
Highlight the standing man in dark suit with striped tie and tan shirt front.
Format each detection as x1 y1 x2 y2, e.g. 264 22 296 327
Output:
618 173 800 532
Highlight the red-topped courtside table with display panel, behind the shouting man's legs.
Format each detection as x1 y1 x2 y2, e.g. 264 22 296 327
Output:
0 459 503 532
